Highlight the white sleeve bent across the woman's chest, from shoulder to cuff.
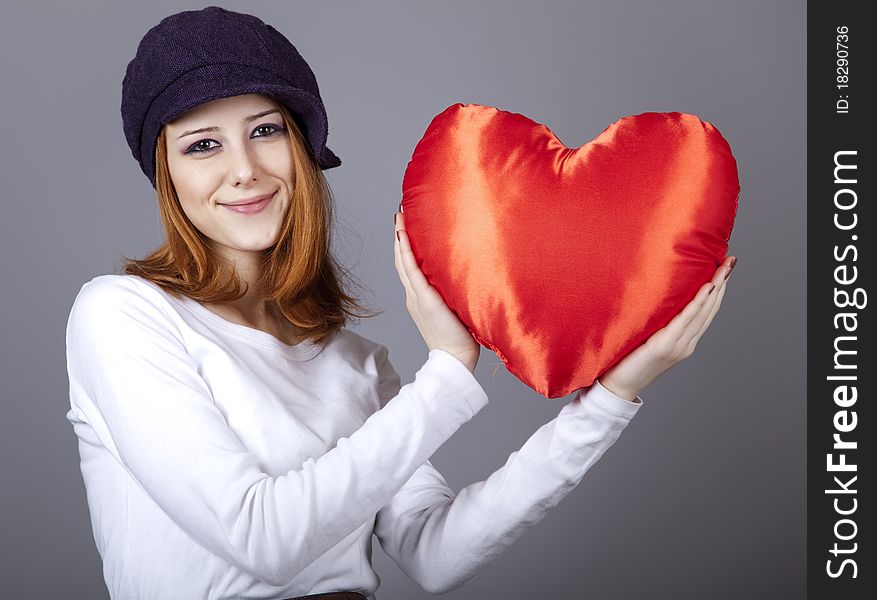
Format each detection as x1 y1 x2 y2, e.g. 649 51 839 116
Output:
66 278 487 585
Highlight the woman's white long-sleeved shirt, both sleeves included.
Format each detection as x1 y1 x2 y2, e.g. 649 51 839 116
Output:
66 275 641 600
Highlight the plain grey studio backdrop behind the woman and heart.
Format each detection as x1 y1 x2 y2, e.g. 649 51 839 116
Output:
0 0 805 600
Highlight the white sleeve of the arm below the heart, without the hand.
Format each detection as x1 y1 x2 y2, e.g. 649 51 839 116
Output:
375 366 642 594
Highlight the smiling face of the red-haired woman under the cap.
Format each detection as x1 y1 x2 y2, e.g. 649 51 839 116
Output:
165 94 295 262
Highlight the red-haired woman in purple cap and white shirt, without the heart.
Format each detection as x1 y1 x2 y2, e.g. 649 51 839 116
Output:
67 7 733 599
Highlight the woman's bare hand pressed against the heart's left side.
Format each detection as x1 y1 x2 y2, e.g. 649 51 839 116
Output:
393 212 481 373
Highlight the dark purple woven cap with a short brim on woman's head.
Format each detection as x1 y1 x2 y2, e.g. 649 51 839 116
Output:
122 6 341 187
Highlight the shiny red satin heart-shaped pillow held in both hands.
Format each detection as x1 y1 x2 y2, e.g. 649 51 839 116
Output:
402 104 740 398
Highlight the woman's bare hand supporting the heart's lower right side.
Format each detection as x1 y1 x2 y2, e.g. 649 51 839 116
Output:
598 256 737 400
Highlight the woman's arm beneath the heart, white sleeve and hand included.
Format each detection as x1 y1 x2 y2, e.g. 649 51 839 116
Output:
375 246 736 593
